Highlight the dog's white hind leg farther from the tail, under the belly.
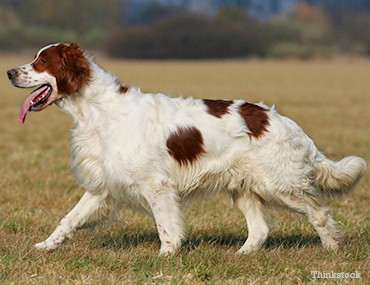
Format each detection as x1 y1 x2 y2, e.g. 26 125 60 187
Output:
232 192 269 254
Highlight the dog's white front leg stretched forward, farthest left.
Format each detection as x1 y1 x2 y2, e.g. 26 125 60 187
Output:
35 192 103 250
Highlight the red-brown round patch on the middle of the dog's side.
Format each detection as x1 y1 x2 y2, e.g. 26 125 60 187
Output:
166 127 205 166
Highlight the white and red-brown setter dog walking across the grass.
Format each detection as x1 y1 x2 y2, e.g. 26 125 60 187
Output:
7 43 366 255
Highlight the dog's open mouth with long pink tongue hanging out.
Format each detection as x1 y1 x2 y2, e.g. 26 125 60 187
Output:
18 84 53 124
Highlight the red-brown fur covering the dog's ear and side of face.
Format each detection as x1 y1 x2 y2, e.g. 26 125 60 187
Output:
32 43 91 94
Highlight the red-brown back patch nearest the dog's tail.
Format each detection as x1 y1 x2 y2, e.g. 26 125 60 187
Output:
239 102 269 138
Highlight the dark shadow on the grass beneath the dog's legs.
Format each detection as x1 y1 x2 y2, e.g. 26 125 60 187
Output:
94 231 321 251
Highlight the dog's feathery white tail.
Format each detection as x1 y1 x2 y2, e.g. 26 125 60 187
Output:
314 154 366 196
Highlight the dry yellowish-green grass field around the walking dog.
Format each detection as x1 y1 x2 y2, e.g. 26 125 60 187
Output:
0 56 370 284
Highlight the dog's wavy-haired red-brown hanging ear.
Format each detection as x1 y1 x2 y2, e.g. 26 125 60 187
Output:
57 43 90 94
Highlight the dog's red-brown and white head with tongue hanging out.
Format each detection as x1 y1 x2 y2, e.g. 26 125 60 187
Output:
7 43 90 123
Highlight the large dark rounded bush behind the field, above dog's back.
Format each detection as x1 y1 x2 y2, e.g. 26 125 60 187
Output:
106 13 266 59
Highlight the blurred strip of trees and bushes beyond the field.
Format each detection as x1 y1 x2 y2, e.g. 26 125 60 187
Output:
0 0 370 59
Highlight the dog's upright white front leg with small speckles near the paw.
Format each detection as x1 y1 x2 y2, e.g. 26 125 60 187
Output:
144 183 185 255
